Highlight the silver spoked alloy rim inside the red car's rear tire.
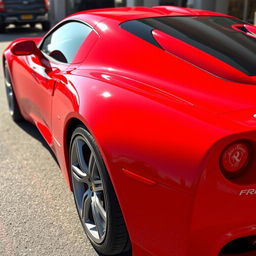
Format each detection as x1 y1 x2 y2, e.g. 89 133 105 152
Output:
71 135 108 244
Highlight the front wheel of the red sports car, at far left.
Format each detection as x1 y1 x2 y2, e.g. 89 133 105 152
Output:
4 62 23 122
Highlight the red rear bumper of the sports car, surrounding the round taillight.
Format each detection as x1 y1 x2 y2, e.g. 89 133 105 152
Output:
188 132 256 256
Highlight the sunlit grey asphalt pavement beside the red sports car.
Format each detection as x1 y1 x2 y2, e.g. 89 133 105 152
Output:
0 27 98 256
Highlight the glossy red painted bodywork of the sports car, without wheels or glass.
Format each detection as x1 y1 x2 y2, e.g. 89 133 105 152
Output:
4 7 256 256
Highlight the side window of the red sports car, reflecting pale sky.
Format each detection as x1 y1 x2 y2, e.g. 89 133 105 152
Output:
40 21 92 63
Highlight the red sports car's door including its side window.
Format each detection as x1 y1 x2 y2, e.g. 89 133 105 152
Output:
27 21 92 145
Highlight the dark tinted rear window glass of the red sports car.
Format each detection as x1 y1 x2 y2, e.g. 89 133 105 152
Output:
121 16 256 76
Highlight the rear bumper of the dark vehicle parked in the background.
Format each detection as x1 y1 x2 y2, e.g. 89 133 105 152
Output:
0 13 48 25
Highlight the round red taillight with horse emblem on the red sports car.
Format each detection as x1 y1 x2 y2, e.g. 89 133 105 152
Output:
220 141 252 178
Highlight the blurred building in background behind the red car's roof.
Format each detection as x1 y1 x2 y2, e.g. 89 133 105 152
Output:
50 0 256 24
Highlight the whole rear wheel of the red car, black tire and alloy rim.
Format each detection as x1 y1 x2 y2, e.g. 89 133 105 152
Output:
69 126 131 255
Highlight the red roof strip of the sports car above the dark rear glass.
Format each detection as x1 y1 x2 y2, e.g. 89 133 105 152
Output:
71 6 228 23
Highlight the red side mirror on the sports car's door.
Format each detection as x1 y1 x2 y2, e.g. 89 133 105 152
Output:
11 40 40 56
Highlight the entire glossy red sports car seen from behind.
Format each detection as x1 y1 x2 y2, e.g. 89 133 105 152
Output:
3 6 256 256
